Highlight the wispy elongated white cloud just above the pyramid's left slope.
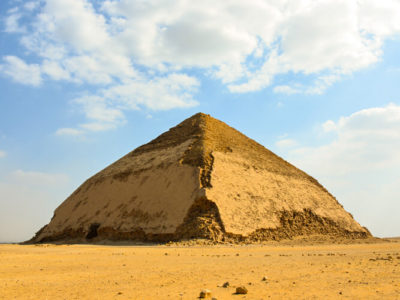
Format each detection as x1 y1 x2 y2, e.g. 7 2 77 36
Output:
56 73 199 135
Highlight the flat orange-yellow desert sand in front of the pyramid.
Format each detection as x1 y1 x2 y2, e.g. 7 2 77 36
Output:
0 240 400 300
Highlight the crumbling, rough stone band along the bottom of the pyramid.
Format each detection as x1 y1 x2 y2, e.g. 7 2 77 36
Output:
27 206 372 244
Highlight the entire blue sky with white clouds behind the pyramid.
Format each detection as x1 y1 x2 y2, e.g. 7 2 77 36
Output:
0 0 400 242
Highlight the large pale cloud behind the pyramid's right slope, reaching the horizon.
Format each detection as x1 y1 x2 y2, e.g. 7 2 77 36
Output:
284 104 400 236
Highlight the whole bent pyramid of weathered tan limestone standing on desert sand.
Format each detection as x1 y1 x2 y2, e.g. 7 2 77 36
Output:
31 113 371 242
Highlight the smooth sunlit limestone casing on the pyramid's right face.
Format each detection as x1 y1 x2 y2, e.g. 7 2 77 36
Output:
207 152 364 235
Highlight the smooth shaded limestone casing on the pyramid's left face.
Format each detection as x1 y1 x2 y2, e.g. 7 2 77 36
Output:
38 141 199 239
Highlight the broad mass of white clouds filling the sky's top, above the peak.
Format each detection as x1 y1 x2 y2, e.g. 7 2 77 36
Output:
0 0 400 129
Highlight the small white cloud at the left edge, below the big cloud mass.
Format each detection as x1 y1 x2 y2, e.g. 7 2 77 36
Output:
0 56 42 86
